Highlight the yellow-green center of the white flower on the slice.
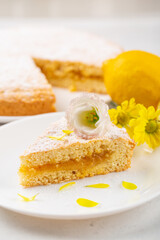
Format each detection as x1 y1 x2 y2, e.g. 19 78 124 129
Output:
80 109 99 128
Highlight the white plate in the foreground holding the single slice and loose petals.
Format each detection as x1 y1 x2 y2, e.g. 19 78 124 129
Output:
0 113 160 219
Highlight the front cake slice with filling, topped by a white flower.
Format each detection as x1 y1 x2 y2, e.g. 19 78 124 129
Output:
19 95 135 187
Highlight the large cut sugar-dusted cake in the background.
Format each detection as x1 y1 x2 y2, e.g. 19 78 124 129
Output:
0 27 123 116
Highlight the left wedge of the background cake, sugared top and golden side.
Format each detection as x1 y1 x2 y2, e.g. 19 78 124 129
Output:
0 56 55 116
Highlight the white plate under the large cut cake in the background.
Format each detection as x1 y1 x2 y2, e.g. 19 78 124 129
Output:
0 87 111 124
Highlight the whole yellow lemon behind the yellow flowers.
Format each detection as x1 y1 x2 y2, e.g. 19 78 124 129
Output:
103 50 160 107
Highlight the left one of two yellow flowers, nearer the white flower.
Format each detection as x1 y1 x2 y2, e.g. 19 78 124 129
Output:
108 98 140 130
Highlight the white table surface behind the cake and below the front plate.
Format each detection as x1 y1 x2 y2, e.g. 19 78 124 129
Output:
0 18 160 240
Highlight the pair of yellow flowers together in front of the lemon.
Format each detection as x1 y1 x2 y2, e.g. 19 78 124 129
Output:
109 98 160 149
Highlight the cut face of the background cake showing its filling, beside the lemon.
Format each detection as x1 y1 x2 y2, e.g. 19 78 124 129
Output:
33 58 106 94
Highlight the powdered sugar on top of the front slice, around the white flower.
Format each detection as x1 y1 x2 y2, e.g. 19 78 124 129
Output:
24 118 129 155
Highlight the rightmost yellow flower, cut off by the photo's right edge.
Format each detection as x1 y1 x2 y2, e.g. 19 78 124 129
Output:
129 106 160 149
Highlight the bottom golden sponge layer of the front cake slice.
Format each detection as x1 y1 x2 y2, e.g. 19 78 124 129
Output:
19 152 133 187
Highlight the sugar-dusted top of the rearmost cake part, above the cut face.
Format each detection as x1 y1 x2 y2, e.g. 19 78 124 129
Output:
0 27 122 67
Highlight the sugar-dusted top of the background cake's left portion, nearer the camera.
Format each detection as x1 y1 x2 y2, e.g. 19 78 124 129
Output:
0 56 51 97
